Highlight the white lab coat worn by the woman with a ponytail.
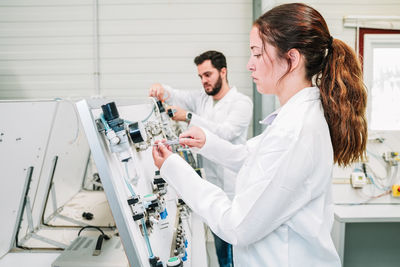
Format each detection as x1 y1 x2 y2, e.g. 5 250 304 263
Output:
161 87 340 267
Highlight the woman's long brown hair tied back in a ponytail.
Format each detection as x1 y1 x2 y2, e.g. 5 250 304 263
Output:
254 3 367 166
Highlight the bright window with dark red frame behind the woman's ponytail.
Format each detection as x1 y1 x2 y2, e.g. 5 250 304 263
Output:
360 29 400 131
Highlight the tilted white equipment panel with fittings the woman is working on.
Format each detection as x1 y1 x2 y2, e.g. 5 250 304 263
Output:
77 99 207 267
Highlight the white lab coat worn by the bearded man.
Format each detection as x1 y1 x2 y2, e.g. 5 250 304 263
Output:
163 85 253 198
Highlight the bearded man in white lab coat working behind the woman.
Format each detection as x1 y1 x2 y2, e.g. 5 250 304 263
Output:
149 51 253 267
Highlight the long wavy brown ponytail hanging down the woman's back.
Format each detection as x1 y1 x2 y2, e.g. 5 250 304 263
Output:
316 39 367 166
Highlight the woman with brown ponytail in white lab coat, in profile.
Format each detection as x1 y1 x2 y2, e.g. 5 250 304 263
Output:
153 4 367 267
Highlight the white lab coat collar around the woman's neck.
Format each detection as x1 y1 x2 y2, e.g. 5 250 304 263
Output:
259 87 320 125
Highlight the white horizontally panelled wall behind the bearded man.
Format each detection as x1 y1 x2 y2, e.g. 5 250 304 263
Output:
0 0 252 99
